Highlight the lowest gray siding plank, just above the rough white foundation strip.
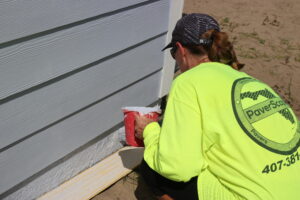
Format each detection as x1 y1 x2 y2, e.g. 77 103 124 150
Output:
0 73 161 194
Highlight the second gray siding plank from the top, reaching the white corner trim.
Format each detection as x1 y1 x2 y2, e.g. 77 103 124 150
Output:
0 0 168 100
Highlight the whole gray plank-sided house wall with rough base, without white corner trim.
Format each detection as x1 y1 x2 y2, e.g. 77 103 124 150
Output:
0 0 171 199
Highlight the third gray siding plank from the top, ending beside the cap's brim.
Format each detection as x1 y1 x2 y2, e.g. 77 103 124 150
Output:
0 35 165 149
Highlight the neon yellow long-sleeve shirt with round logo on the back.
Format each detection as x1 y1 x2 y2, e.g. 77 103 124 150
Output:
143 62 300 200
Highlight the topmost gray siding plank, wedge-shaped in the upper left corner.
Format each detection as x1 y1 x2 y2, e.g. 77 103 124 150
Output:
0 0 149 44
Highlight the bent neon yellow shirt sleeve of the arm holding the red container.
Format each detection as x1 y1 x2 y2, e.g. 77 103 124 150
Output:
143 77 203 182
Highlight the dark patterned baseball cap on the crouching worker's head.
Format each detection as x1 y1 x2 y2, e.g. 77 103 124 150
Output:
162 13 220 51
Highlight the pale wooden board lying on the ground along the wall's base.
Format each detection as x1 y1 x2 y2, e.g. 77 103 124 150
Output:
38 147 144 200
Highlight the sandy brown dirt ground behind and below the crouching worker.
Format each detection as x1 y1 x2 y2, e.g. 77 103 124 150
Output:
92 0 300 200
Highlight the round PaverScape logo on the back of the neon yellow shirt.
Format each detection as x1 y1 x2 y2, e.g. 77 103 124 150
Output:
232 78 300 155
